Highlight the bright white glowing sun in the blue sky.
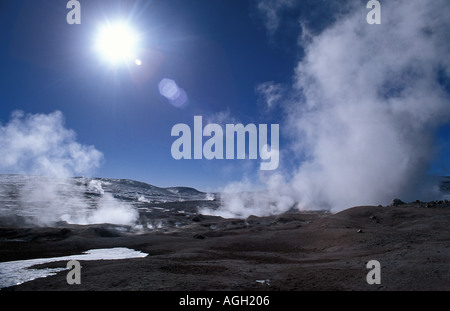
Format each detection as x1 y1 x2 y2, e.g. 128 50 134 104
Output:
95 22 141 65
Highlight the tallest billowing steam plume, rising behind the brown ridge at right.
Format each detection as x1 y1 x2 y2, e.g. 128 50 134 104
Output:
206 0 450 217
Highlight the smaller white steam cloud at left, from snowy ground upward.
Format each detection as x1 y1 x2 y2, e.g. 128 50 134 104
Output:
0 111 137 225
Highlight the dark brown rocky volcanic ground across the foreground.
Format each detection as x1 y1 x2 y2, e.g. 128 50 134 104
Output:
0 202 450 291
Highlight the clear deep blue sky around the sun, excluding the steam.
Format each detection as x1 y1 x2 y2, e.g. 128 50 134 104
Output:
0 0 450 194
